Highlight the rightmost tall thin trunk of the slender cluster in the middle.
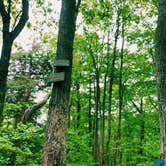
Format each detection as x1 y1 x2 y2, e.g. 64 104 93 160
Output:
114 22 124 166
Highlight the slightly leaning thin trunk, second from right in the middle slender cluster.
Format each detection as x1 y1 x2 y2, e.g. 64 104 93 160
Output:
105 14 119 166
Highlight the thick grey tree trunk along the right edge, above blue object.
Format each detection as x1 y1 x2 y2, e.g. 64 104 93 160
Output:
156 0 166 160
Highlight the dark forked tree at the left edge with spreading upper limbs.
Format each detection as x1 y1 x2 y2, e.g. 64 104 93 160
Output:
0 0 29 124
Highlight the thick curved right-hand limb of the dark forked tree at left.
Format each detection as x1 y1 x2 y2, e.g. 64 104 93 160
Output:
11 0 29 40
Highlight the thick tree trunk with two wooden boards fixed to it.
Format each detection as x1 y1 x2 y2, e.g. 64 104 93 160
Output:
42 0 81 166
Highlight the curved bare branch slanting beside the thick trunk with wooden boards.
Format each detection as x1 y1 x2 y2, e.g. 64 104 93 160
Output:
21 94 51 123
